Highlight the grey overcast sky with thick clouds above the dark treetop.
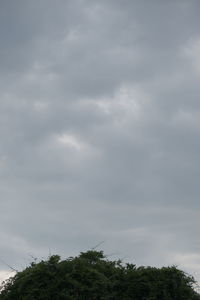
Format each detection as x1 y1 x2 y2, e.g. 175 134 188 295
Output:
0 0 200 284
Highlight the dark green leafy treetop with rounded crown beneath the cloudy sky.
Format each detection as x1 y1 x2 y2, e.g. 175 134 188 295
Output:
0 251 200 300
